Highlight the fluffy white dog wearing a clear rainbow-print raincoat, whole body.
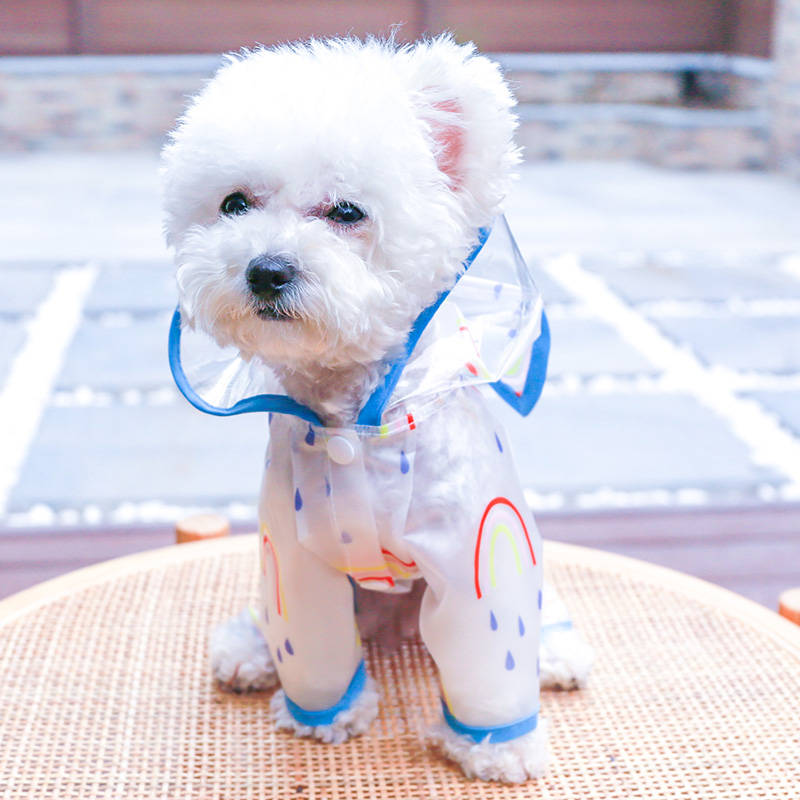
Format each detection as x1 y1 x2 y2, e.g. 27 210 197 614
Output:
163 37 591 781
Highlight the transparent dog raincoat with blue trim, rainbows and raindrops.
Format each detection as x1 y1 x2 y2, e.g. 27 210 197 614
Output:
170 217 549 741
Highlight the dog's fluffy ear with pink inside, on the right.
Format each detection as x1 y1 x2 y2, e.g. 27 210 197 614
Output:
409 35 520 219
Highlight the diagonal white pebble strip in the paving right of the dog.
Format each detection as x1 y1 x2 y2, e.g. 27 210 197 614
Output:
543 253 800 499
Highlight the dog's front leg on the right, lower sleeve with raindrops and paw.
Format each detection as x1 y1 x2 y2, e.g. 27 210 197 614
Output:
418 534 547 783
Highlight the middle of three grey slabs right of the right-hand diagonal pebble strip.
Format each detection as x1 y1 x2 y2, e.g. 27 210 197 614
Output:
654 316 800 372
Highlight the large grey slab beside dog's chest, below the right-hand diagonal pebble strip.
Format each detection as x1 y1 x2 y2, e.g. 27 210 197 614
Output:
484 394 785 494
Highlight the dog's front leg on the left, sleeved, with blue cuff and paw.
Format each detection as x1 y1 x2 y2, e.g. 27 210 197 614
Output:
263 541 378 742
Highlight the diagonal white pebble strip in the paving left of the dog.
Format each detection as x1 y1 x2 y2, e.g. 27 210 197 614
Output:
0 264 99 516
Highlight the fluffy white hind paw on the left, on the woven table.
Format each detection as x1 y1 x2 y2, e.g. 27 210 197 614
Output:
208 608 278 692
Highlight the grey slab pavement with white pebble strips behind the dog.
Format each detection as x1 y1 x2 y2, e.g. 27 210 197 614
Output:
0 153 800 529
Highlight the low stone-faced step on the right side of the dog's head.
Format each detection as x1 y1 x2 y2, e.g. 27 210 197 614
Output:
497 53 772 169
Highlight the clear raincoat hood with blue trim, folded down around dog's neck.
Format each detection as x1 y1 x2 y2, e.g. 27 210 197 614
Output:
169 216 550 428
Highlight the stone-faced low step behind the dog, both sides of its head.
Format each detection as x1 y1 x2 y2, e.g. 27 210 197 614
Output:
0 53 772 169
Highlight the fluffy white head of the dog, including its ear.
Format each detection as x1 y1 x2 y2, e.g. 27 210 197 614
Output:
162 37 518 367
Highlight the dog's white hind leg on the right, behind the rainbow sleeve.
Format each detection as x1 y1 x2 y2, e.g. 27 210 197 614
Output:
539 583 594 689
